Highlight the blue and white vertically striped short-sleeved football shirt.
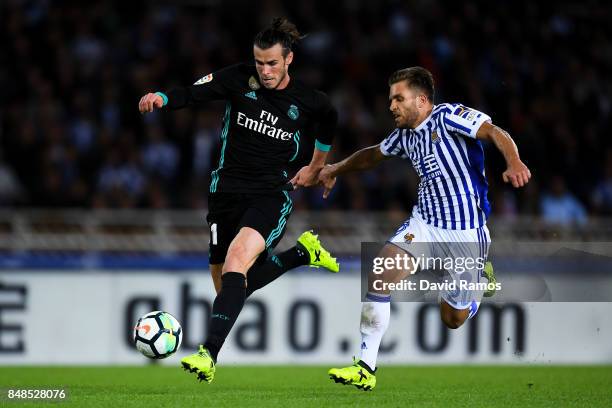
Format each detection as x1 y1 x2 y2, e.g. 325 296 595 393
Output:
380 103 491 230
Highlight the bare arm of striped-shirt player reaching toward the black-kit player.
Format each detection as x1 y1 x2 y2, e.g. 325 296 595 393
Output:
319 145 391 198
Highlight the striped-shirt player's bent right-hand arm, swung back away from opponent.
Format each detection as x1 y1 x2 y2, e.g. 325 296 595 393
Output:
476 122 531 188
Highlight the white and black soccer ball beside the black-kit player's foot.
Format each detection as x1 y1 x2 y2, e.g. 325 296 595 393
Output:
134 310 183 359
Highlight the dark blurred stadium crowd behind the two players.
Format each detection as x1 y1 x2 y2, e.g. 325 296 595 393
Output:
0 0 612 224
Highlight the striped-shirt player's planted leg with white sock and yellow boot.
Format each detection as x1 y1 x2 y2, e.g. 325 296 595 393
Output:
328 244 412 391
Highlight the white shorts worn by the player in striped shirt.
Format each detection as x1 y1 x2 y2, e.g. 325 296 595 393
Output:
388 212 491 309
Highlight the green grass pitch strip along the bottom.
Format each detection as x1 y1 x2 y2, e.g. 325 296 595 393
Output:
0 366 612 408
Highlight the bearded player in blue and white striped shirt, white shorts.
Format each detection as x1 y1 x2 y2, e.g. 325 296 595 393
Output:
319 67 531 390
